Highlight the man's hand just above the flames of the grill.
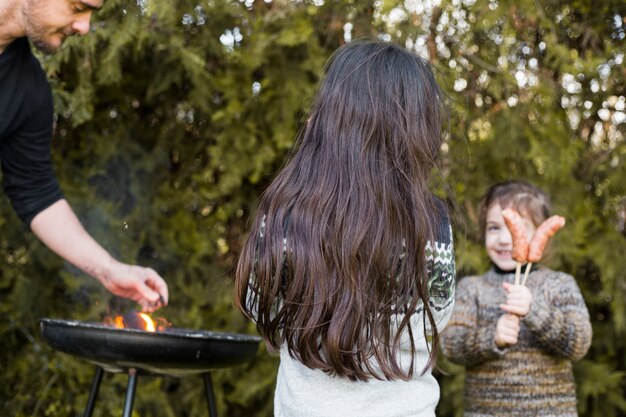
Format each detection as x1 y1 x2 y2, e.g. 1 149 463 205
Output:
96 260 169 312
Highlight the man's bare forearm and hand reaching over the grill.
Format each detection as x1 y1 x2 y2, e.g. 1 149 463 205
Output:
30 199 168 311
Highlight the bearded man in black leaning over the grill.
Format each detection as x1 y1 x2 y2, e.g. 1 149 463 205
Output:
0 0 168 311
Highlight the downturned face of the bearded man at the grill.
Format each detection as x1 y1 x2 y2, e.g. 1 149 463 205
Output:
23 0 104 54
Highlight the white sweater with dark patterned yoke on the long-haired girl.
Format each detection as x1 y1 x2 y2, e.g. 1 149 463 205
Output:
274 225 455 417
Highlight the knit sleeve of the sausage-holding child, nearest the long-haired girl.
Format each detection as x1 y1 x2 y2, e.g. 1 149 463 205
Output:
441 277 506 366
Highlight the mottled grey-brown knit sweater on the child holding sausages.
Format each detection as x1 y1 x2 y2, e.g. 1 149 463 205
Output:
441 268 591 417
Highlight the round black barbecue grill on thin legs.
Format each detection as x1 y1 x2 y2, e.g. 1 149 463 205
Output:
39 319 261 417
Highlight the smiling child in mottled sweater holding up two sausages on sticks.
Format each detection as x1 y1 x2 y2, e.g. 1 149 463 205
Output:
441 181 591 417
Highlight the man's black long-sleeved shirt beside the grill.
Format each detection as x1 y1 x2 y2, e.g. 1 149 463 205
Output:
0 38 63 226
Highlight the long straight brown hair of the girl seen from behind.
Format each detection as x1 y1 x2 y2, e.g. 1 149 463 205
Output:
235 41 443 380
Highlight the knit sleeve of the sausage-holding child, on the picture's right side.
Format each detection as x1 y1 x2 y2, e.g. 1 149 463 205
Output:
523 273 592 361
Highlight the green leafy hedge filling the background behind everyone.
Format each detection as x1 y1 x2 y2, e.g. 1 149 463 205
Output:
0 0 626 417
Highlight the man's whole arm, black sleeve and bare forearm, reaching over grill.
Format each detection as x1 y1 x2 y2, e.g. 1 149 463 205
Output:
0 39 168 311
